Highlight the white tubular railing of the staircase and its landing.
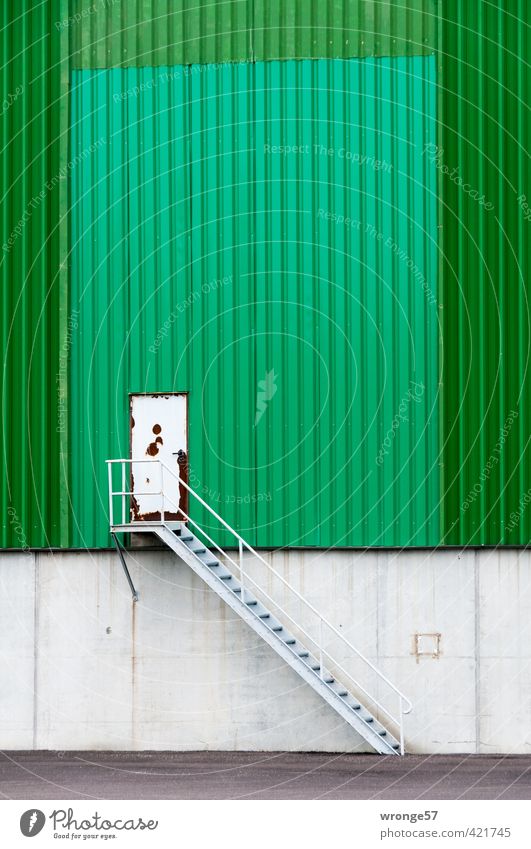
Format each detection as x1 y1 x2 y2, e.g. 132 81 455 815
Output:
106 458 413 754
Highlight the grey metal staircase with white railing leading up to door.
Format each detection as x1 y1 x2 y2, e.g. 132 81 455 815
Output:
107 459 412 755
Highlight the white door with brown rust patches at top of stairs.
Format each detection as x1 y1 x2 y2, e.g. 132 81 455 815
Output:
130 393 188 521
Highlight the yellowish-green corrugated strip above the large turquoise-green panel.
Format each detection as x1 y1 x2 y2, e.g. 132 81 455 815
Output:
69 0 437 68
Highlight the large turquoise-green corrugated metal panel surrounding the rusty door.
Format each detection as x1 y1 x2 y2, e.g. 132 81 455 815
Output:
70 57 439 546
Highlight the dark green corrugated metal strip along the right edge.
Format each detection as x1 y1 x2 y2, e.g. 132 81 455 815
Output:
438 0 531 545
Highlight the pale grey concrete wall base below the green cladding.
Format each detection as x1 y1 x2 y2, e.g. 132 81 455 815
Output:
0 550 531 753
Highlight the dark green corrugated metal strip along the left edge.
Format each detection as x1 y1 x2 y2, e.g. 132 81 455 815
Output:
0 0 68 548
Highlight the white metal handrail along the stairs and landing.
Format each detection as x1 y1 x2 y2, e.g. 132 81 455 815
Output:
106 458 413 754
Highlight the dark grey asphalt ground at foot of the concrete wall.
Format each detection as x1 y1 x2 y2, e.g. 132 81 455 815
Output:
0 751 531 800
